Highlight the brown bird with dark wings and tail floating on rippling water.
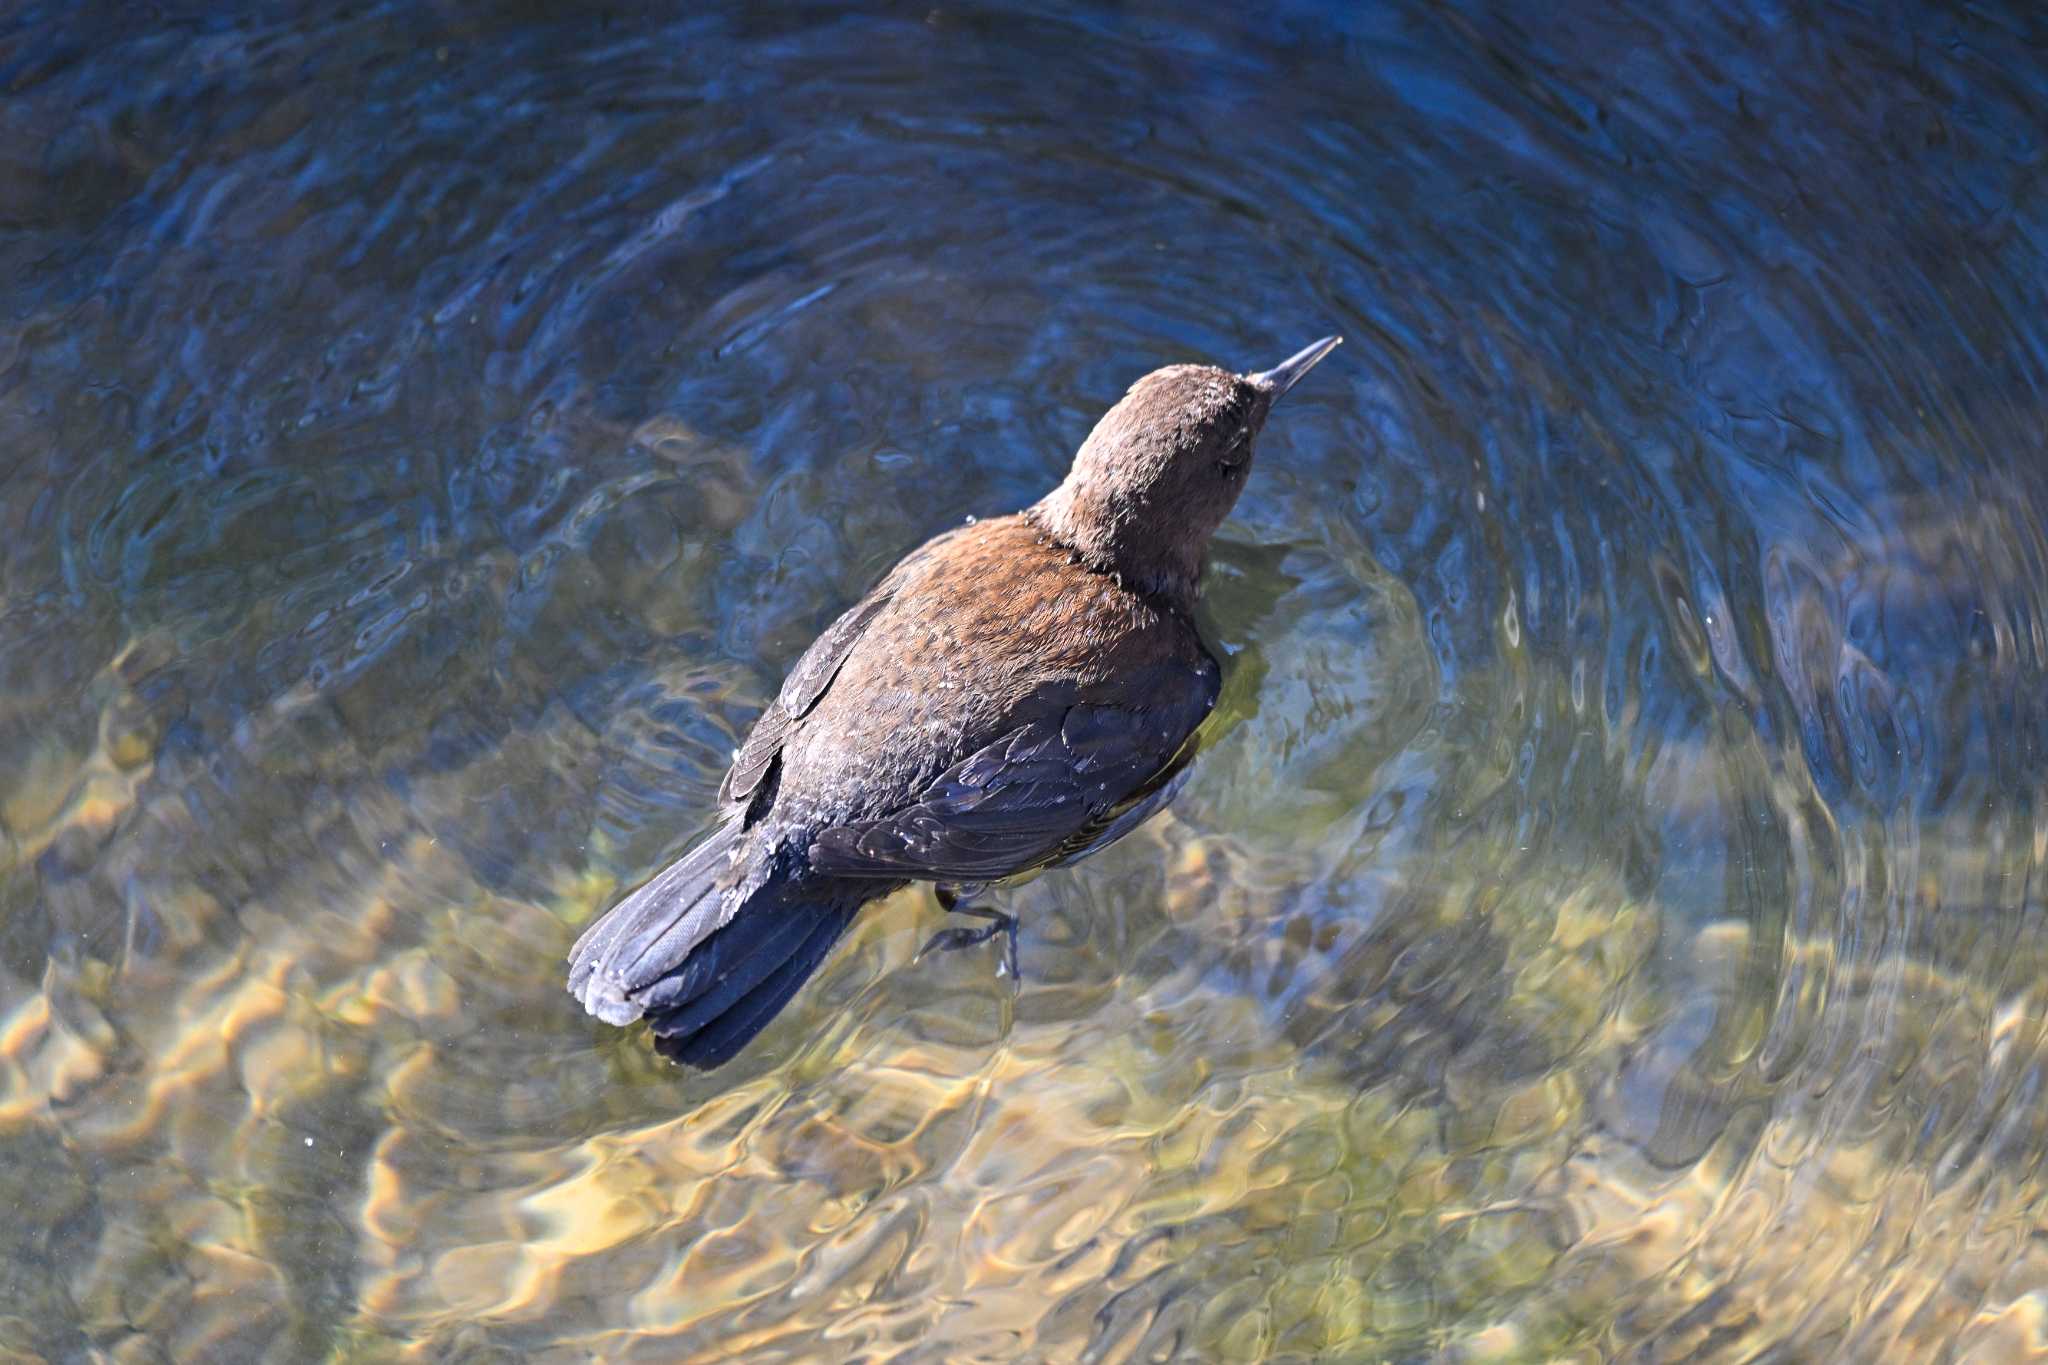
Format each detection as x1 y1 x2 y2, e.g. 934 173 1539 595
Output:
567 336 1341 1068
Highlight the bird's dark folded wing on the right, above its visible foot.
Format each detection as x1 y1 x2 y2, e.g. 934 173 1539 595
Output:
811 698 1208 882
